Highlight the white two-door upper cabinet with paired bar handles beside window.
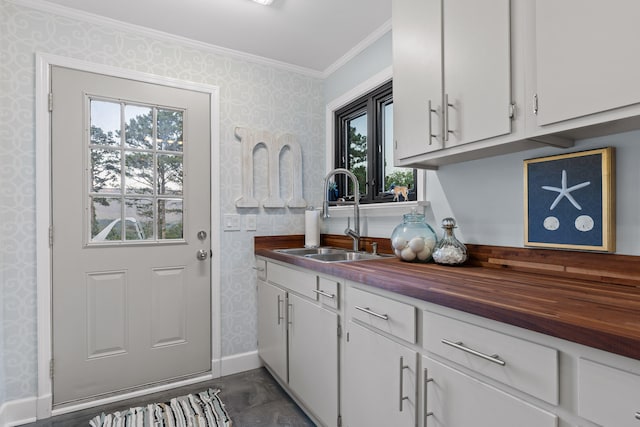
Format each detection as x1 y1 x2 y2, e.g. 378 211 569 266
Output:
393 0 512 164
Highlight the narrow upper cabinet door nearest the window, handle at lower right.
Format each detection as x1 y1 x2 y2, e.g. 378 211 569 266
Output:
393 0 442 159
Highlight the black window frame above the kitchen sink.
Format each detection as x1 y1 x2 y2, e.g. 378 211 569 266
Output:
332 79 419 204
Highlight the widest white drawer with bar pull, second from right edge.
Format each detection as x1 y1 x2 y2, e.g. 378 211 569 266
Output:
423 311 559 405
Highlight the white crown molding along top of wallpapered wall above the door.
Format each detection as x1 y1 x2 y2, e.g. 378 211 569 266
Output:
13 0 324 79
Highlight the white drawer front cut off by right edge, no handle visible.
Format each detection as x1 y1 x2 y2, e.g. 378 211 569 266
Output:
578 358 640 427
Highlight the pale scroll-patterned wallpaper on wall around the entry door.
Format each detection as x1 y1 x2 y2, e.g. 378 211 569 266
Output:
0 0 324 404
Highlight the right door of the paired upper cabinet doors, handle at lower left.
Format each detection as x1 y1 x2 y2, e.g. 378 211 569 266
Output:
443 0 512 147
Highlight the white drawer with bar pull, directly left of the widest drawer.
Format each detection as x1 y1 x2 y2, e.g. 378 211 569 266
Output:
347 288 416 343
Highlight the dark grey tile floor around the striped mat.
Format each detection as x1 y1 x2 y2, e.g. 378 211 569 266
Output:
23 368 315 427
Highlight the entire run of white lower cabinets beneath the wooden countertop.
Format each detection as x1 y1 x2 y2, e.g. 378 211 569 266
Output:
257 260 640 427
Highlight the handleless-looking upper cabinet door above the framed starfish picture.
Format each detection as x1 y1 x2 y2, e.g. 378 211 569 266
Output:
535 0 640 125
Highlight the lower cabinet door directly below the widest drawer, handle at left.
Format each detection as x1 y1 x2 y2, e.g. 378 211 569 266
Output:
422 357 558 427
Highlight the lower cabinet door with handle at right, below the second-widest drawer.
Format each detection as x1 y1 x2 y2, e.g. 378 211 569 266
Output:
342 322 418 427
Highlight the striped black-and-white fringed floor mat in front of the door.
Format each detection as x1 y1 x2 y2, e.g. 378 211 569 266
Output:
89 389 231 427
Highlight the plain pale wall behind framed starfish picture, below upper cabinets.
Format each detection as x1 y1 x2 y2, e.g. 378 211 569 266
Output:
427 131 640 255
